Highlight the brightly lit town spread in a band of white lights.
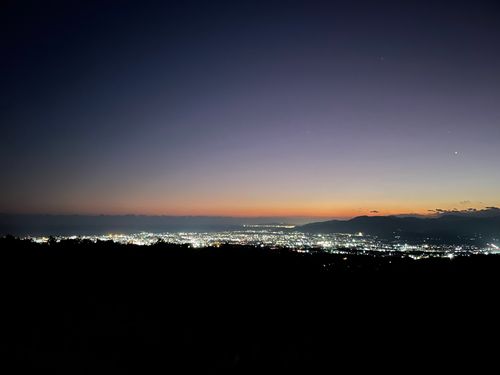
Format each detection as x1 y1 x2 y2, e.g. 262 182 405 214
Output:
26 225 500 259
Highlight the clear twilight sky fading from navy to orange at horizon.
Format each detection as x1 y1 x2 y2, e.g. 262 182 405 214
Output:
0 0 500 217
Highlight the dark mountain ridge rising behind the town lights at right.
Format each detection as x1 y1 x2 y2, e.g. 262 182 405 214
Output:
296 208 500 244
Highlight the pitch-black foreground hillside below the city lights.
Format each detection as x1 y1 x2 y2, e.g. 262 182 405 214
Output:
0 238 500 374
